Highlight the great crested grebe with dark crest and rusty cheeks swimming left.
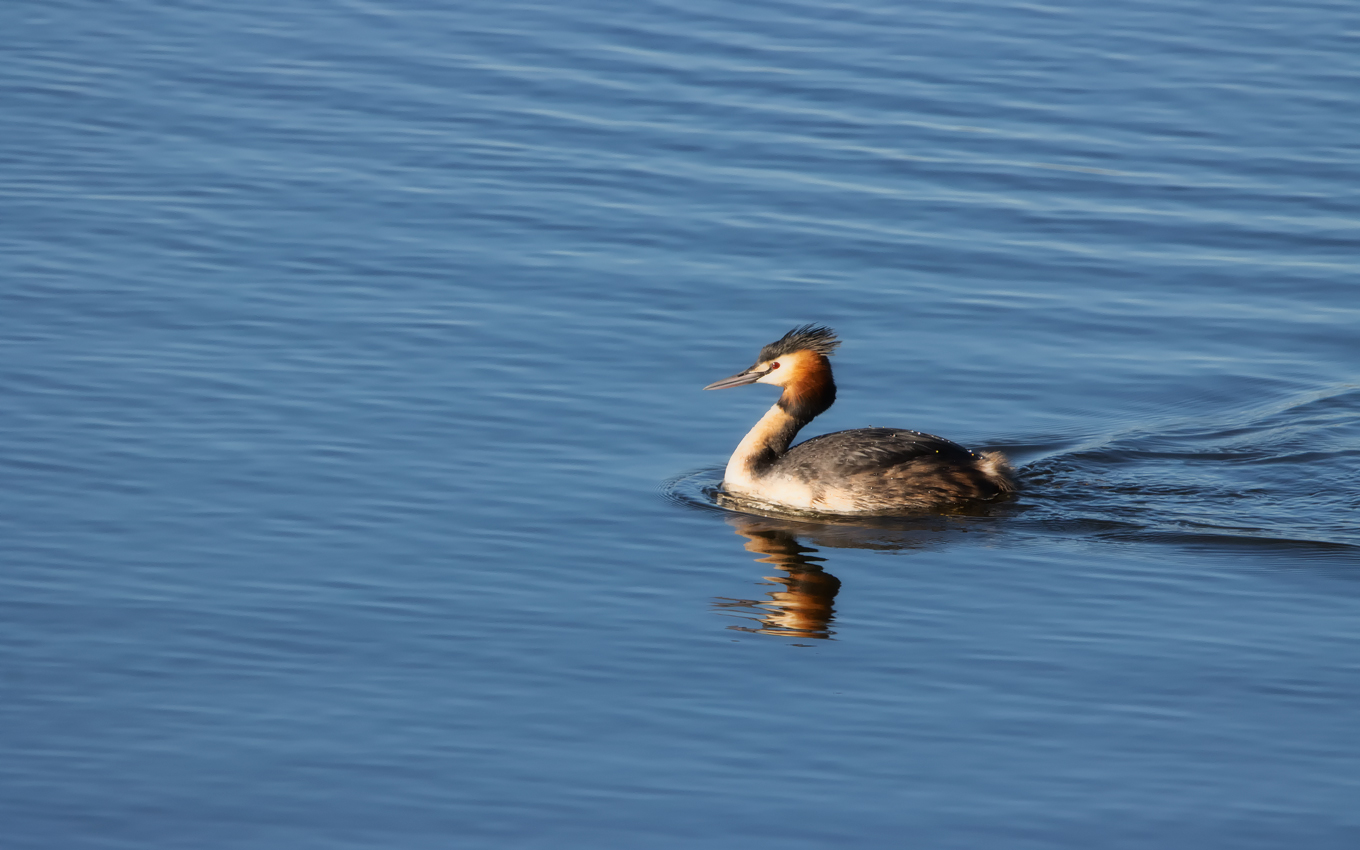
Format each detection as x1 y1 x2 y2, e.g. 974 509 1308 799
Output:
703 325 1015 514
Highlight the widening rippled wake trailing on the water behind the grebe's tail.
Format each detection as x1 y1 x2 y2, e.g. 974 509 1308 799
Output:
1023 386 1360 555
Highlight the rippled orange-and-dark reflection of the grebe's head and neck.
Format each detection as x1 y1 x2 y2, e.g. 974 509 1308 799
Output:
715 515 840 639
